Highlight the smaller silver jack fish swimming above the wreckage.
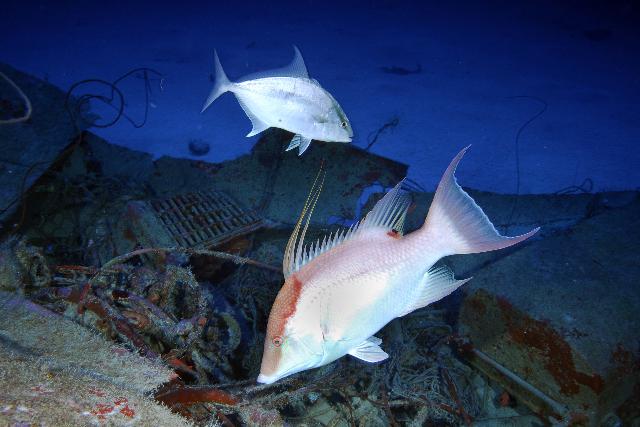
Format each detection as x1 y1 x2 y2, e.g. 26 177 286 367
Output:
202 46 353 155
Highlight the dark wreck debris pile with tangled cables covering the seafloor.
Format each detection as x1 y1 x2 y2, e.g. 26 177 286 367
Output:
0 66 640 426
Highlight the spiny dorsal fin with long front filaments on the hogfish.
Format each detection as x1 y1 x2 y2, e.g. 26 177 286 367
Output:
283 179 411 277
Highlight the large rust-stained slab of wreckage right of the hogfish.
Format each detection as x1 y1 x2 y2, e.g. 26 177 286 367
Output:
460 194 640 424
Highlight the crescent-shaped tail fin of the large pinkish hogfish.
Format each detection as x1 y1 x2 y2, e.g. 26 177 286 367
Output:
421 146 540 256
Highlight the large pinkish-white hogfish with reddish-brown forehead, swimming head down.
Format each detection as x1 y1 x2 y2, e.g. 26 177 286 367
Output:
258 147 538 383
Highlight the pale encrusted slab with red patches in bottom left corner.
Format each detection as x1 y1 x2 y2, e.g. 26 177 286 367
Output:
0 292 189 426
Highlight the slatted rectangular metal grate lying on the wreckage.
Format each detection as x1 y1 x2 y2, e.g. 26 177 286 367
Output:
150 190 262 248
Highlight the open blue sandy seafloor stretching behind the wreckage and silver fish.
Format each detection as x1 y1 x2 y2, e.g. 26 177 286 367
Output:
0 1 640 193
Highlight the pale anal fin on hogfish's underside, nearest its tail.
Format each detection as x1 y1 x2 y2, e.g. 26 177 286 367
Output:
398 266 471 317
